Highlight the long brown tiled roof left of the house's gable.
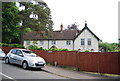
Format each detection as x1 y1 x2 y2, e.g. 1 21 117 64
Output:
24 30 80 40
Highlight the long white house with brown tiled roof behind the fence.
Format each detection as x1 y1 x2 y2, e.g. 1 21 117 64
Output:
24 23 99 52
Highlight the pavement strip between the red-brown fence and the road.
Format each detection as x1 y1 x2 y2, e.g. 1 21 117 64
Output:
43 65 120 80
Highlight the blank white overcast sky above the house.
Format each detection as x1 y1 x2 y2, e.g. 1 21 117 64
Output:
43 0 120 43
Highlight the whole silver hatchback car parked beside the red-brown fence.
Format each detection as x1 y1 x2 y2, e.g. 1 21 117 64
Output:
5 49 45 69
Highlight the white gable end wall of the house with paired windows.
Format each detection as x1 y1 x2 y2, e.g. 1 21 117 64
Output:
74 29 98 51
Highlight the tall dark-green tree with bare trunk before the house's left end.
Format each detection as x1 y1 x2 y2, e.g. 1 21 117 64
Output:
18 2 53 44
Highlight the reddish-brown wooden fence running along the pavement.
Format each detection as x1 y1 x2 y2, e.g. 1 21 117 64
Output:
3 47 120 75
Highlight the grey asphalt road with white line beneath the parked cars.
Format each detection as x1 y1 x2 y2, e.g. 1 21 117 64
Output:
0 60 67 80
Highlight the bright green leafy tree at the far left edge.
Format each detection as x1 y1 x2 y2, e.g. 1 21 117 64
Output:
2 2 20 43
